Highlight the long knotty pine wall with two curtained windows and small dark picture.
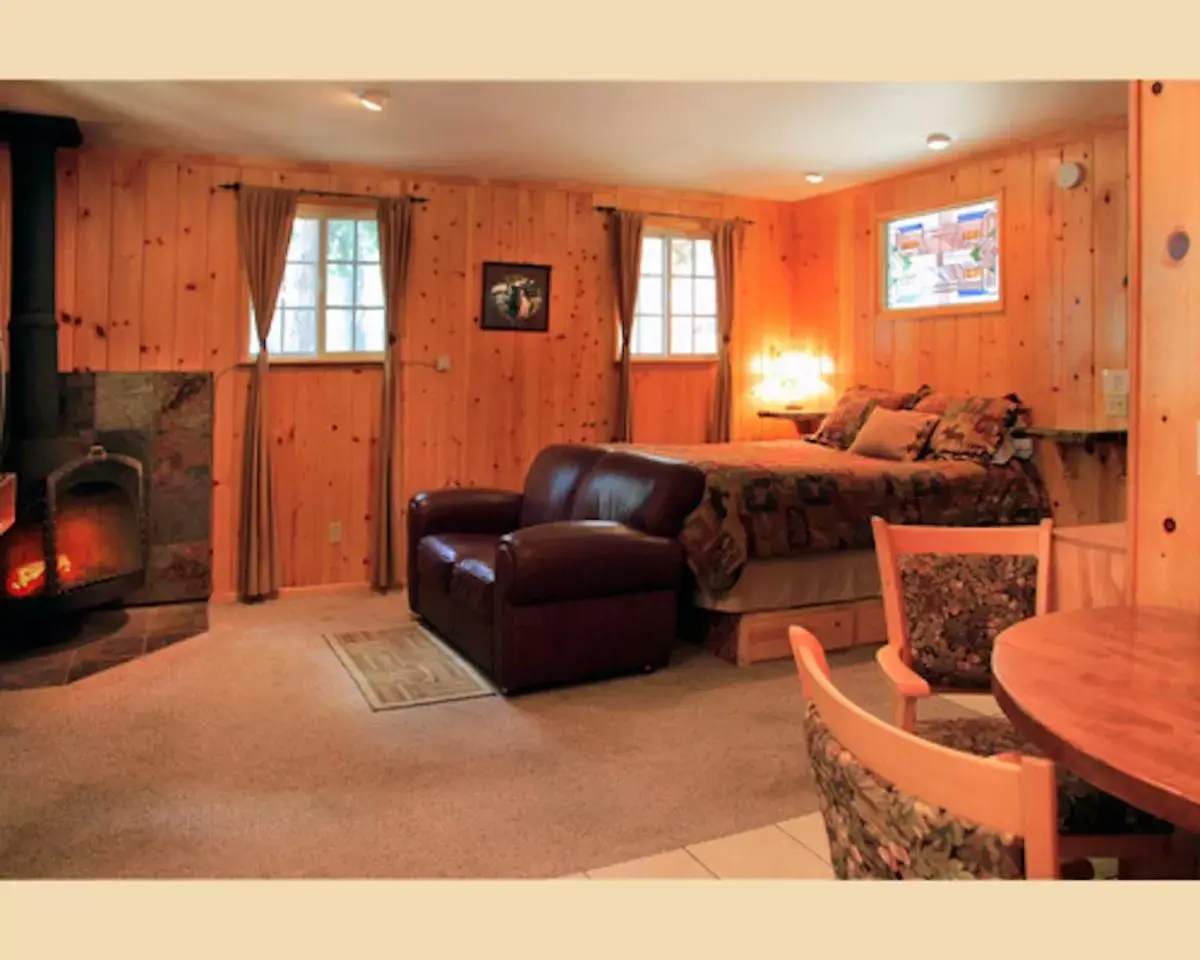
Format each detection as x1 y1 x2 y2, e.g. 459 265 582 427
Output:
0 149 792 594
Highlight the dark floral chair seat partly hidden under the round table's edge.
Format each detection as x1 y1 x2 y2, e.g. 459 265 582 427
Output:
913 716 1174 836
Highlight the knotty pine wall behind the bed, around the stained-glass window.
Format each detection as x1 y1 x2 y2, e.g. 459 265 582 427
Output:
793 124 1128 523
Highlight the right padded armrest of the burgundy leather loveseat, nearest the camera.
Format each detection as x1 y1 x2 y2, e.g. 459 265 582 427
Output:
496 520 684 604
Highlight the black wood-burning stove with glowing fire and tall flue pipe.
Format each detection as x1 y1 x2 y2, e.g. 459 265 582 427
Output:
0 112 148 641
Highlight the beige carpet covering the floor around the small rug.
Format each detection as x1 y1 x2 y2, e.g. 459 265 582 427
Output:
0 592 967 877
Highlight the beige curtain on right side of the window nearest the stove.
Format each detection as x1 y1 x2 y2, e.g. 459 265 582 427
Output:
371 197 413 592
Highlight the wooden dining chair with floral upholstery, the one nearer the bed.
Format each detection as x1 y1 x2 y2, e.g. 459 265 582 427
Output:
871 517 1174 864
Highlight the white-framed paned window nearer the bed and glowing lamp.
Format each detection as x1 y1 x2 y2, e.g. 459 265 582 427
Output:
618 230 716 360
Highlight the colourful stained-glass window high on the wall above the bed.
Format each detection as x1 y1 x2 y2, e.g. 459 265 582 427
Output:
880 196 1004 318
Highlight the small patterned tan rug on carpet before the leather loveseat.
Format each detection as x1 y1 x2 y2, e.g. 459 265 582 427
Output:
325 623 496 710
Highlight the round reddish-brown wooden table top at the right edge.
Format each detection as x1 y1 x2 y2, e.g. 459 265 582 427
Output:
991 607 1200 832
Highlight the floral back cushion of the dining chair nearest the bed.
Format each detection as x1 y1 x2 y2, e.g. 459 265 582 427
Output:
898 553 1038 690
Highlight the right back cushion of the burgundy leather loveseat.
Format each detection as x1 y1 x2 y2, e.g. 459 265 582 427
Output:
571 450 704 536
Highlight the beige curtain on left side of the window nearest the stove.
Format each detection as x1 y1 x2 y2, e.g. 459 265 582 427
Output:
238 186 296 602
